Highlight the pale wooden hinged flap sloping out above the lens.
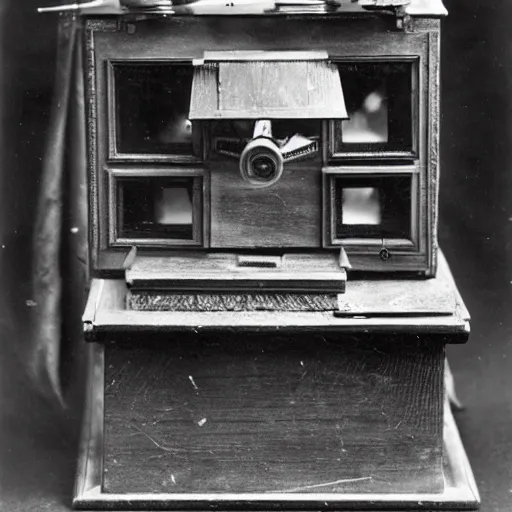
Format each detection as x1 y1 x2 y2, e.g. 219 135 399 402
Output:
189 51 348 120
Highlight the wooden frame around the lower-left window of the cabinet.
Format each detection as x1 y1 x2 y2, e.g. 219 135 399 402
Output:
105 167 210 247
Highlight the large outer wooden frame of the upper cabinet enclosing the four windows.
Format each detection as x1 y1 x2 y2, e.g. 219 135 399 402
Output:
85 13 440 277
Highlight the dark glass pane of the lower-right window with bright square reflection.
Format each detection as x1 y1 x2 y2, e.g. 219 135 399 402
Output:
334 176 411 239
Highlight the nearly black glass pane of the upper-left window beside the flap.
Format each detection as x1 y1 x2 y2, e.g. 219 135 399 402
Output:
114 64 200 156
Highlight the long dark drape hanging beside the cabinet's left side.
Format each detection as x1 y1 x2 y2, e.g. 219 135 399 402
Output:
30 15 87 401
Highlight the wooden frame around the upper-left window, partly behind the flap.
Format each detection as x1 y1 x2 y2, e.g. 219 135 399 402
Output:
105 59 206 164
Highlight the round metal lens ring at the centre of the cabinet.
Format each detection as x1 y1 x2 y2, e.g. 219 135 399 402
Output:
240 137 284 187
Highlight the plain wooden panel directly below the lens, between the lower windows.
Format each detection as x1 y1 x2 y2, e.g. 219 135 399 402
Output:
210 161 322 248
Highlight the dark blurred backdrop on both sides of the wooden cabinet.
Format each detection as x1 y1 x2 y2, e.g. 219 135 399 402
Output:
0 0 512 512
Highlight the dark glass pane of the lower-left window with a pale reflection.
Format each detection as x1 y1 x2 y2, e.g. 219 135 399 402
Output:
117 177 194 240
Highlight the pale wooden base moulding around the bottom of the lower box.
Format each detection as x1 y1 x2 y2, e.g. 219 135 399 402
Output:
73 344 479 511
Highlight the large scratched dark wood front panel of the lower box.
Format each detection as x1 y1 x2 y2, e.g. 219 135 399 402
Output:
104 335 444 493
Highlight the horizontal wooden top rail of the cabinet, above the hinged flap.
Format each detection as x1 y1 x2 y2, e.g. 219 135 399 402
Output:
95 16 427 60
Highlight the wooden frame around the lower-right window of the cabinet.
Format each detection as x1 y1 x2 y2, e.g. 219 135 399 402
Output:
322 165 420 253
